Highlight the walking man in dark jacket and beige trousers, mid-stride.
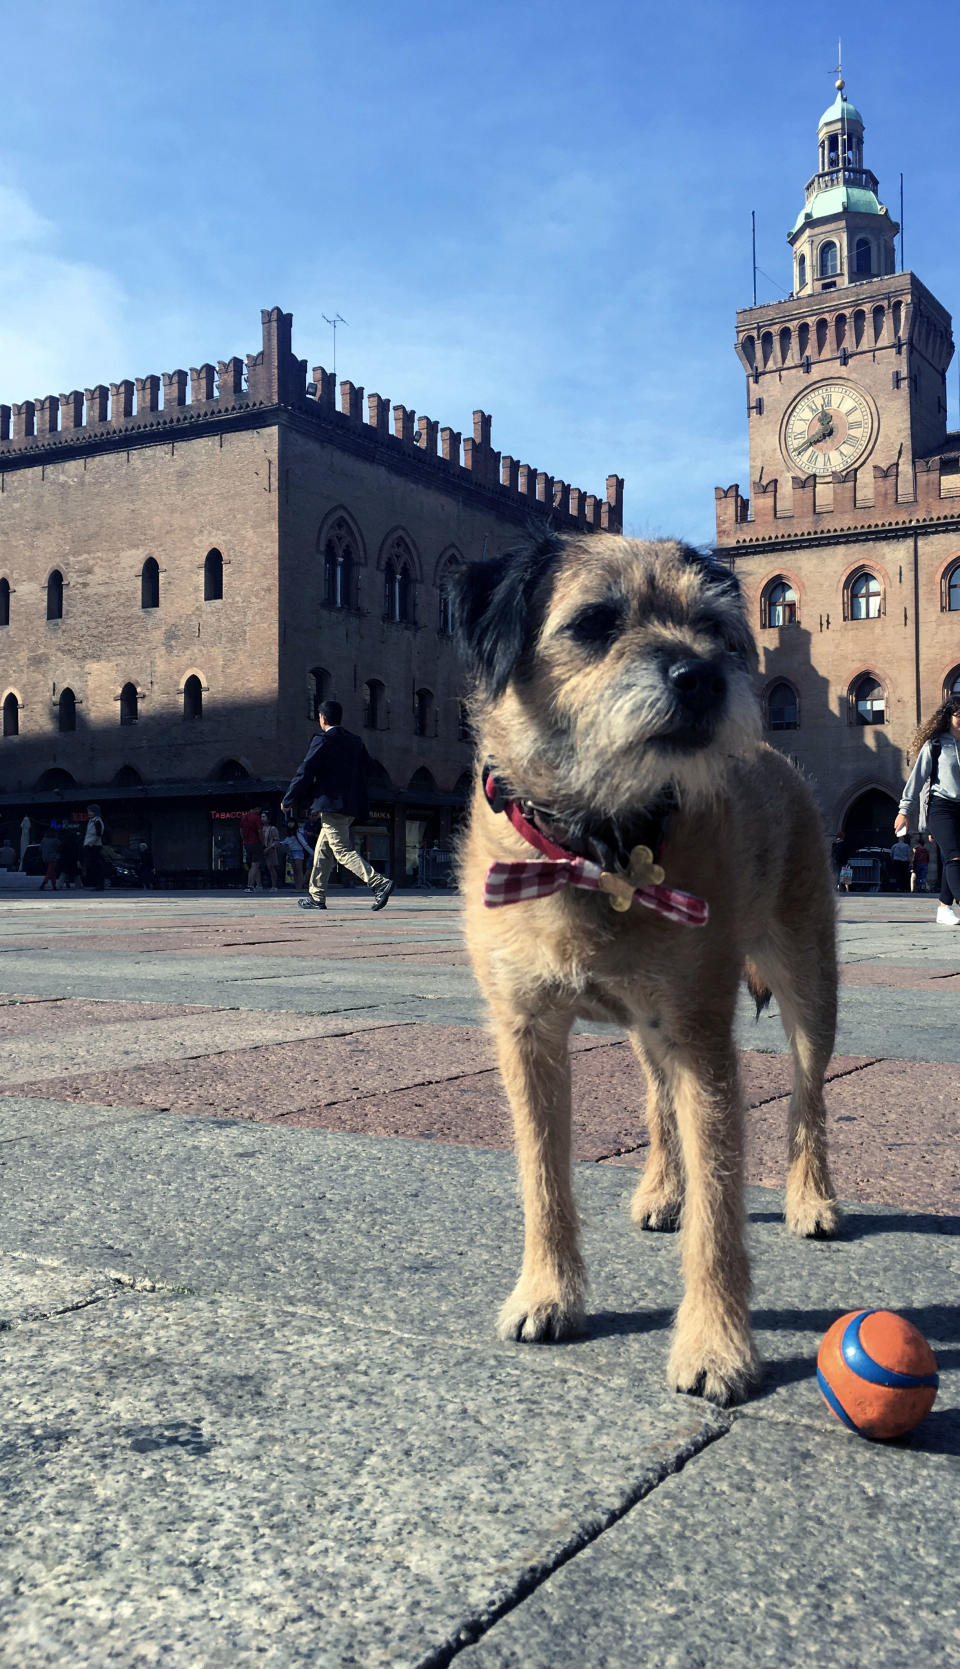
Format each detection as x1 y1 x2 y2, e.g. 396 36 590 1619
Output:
280 701 394 910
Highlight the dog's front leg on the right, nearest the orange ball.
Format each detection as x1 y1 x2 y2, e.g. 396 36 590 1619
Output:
666 1033 758 1404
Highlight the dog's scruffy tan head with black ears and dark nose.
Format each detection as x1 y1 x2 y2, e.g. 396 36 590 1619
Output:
457 534 760 816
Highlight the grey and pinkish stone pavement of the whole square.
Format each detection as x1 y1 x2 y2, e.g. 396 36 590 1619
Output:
0 876 960 1669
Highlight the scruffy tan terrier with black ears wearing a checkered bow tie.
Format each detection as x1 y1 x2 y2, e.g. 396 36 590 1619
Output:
454 532 838 1404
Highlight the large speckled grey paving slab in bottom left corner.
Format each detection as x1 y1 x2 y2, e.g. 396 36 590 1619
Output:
0 1295 728 1669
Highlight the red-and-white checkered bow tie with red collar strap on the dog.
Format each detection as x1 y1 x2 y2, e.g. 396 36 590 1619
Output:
484 774 710 928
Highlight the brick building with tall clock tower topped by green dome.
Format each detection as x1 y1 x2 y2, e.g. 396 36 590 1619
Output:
716 80 960 850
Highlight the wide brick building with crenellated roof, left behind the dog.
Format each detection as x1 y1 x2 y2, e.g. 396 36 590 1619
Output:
0 309 623 878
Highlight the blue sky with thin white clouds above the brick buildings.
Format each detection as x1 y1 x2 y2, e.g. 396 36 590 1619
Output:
0 0 960 542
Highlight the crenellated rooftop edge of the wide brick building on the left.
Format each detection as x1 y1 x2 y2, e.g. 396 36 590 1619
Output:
0 307 623 532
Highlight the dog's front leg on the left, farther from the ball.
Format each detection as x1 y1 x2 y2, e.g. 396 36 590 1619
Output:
494 1010 584 1339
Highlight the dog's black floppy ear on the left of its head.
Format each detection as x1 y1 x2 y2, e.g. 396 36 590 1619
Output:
452 532 563 698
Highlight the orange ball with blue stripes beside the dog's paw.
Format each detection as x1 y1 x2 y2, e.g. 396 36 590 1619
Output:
816 1310 940 1439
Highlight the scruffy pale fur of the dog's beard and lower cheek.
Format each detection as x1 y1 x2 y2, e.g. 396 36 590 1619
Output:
479 666 760 819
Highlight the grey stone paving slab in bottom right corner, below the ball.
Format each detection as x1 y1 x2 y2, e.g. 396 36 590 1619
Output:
457 1417 960 1669
